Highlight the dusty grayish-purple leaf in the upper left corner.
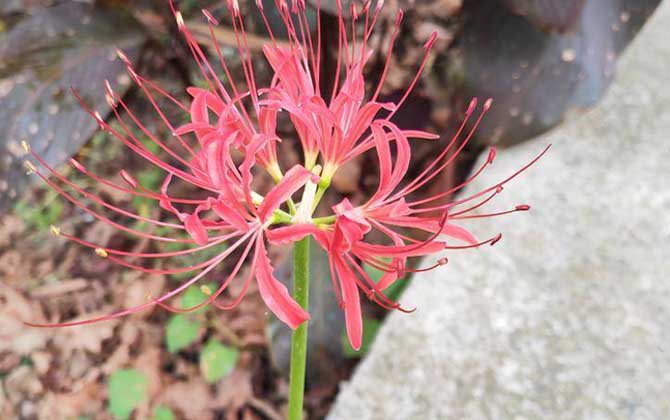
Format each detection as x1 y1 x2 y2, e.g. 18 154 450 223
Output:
0 2 144 208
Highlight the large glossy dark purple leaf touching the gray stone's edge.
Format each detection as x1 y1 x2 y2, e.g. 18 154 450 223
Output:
446 0 660 143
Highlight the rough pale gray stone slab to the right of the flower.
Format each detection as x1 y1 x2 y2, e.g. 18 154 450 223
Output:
329 1 670 420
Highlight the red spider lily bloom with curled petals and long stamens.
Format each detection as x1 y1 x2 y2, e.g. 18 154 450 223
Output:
24 0 544 349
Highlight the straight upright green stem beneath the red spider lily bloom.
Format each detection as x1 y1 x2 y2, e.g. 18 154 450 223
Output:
288 236 310 420
